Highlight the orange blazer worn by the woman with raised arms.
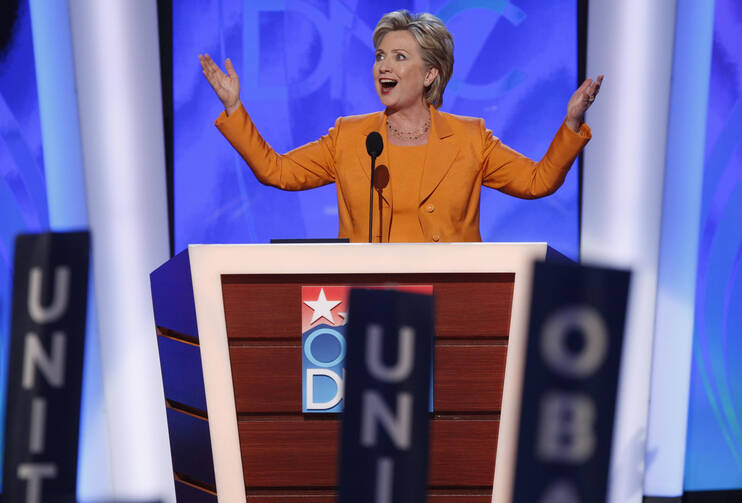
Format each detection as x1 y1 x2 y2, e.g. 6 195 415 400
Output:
215 106 591 242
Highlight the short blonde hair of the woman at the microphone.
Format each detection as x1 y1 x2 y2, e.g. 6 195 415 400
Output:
373 10 453 108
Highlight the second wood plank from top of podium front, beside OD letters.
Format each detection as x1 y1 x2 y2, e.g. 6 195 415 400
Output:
229 343 507 414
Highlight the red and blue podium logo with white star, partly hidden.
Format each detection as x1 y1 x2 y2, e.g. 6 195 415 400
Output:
301 285 433 413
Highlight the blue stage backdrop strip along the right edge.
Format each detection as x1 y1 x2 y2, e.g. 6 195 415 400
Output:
684 0 742 491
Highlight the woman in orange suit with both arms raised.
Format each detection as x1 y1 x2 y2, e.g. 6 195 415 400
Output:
199 10 603 242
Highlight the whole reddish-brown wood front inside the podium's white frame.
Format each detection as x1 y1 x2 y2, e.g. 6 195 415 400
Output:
222 274 514 503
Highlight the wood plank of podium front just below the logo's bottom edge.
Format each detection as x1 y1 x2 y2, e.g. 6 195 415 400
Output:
238 419 499 488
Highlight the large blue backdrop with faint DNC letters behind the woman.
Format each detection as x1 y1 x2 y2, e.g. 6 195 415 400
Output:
173 0 578 258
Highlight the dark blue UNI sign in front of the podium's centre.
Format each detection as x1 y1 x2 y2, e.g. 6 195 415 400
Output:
338 290 434 503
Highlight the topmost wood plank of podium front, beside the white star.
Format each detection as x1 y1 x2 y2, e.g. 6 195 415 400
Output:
222 273 514 340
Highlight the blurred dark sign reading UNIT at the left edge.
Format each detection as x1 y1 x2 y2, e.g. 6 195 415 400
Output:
3 232 90 503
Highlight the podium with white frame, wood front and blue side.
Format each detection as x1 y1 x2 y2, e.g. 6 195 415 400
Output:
151 243 559 503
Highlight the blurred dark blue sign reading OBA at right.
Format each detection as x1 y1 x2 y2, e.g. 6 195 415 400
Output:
513 263 630 503
